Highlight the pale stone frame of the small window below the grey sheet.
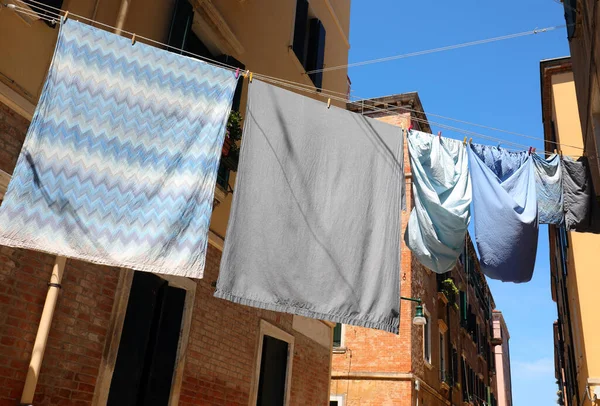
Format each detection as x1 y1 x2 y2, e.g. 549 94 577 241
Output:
248 319 295 406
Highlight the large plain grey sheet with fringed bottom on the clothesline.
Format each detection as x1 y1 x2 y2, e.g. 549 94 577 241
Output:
215 79 404 333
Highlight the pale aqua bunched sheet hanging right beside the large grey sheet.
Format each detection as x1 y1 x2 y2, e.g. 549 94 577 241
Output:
404 130 472 273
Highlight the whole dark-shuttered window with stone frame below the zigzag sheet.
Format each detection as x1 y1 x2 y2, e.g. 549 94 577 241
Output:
95 271 196 405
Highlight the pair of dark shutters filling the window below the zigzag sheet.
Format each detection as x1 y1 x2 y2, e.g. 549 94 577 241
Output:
107 272 186 405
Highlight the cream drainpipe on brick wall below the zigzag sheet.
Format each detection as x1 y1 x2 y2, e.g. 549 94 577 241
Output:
21 257 67 406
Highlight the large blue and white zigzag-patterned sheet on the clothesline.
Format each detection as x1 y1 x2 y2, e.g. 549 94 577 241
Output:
0 19 236 278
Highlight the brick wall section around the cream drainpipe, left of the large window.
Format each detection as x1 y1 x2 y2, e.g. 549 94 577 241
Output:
0 247 118 405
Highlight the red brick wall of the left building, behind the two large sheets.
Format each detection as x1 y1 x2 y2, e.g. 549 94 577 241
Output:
0 99 330 406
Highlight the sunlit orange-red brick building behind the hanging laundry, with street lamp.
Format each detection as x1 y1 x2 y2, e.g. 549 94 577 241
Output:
331 93 504 406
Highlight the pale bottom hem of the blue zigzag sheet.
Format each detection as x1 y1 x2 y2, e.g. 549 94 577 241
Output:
0 237 204 279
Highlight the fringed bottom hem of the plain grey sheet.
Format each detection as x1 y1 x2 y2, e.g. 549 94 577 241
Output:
214 288 400 334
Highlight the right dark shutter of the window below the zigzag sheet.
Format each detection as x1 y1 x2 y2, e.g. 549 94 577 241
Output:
139 285 186 405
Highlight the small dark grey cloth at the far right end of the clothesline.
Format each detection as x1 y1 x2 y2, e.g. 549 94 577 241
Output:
562 156 600 234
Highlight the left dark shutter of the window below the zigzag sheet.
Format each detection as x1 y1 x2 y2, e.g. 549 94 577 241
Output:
107 272 166 405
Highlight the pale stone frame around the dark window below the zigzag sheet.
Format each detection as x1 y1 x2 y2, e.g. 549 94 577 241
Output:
91 269 197 406
